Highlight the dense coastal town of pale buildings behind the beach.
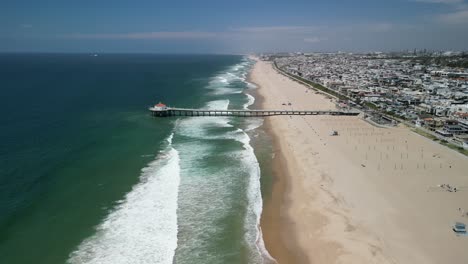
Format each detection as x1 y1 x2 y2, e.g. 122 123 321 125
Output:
262 50 468 150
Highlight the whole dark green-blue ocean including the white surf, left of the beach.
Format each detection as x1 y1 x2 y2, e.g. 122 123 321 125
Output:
0 54 272 264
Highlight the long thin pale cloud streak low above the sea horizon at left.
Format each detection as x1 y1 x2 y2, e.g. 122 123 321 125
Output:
65 31 218 39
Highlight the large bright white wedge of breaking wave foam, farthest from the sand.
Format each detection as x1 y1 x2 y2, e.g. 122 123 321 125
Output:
68 135 180 264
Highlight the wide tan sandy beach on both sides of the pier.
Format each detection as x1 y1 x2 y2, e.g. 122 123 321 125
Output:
251 58 468 263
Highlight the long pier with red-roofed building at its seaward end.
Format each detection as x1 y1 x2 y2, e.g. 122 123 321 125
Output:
149 107 359 117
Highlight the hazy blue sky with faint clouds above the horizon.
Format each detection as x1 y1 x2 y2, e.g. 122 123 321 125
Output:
0 0 468 54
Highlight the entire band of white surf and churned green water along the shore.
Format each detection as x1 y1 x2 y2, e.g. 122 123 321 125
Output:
69 56 274 264
